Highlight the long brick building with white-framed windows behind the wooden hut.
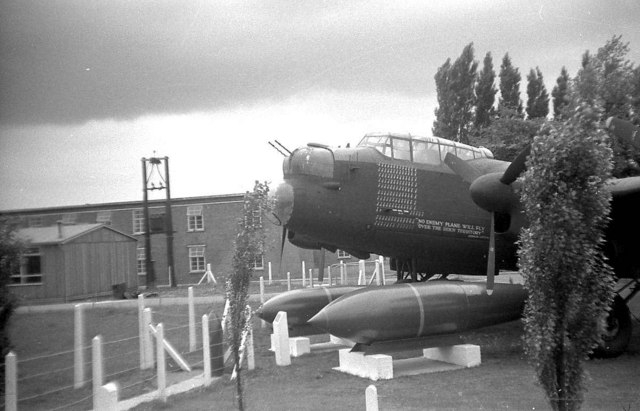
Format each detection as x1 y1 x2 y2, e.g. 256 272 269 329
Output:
0 194 360 300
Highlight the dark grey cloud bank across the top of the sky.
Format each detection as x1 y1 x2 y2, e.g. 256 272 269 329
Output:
0 0 640 124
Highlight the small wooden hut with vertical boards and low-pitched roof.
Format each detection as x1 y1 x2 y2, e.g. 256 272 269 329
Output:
11 223 138 303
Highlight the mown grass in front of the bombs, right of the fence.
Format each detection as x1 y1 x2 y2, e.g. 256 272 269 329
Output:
130 298 640 410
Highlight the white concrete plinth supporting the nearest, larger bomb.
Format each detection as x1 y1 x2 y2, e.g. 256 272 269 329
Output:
334 344 481 381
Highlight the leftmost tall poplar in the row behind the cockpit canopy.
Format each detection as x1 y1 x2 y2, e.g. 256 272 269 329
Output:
432 43 478 144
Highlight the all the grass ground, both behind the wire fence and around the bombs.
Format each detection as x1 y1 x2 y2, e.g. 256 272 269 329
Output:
11 284 640 410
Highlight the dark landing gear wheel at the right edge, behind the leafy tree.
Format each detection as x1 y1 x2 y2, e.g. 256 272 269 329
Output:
593 295 632 358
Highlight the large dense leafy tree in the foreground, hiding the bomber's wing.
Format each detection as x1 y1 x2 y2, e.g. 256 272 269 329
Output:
519 103 615 410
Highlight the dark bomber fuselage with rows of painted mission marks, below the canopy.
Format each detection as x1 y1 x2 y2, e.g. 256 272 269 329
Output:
277 140 516 275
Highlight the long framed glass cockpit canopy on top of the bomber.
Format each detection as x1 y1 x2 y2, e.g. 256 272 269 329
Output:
358 133 493 166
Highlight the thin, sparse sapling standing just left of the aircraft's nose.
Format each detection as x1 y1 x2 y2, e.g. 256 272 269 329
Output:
225 181 271 410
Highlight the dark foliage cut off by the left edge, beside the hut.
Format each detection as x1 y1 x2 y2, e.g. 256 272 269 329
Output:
0 219 24 392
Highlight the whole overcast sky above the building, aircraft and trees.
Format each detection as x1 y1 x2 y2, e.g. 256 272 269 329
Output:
0 0 640 210
